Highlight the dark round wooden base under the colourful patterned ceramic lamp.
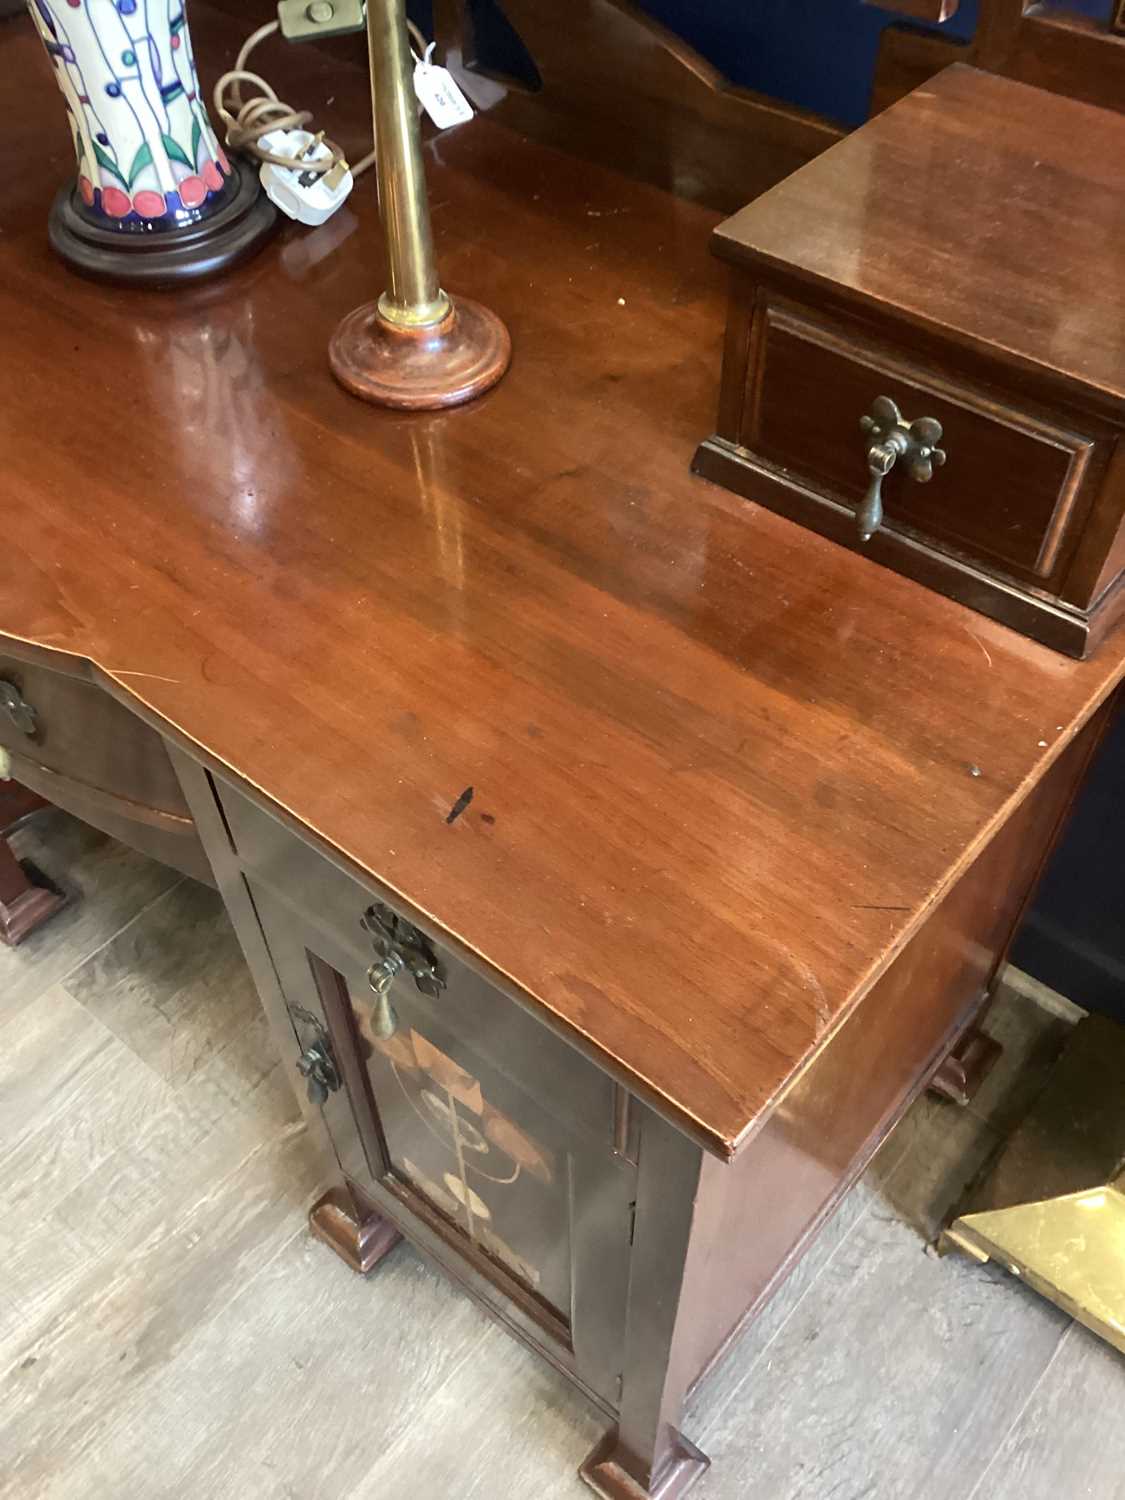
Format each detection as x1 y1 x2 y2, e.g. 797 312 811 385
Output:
48 164 278 287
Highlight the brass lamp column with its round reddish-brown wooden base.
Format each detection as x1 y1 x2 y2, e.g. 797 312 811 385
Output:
329 0 512 410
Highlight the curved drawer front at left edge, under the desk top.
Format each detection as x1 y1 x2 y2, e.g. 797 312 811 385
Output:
0 656 191 825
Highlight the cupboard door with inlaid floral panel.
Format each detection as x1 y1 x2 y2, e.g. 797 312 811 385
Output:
248 878 636 1404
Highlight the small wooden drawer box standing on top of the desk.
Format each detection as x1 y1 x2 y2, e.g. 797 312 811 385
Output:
696 66 1125 656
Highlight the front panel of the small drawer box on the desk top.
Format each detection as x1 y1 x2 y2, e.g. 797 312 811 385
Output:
750 306 1110 584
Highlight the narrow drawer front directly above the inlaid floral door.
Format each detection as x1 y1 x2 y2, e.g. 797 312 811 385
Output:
216 779 615 1140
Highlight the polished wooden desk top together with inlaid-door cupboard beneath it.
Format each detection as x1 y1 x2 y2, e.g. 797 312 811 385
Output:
8 3 1125 1500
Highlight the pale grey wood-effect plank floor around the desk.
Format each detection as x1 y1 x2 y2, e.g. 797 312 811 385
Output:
0 813 1125 1500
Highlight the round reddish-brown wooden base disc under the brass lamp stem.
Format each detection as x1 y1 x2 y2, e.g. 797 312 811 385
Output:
329 297 512 411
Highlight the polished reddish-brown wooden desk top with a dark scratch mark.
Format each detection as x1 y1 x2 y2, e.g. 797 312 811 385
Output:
0 14 1125 1155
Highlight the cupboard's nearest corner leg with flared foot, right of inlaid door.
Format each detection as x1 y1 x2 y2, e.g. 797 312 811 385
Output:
579 1112 714 1500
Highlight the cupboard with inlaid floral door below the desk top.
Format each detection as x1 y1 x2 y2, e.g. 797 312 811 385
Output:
162 708 1110 1500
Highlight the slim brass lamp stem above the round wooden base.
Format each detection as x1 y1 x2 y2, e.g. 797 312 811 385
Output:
368 0 450 329
